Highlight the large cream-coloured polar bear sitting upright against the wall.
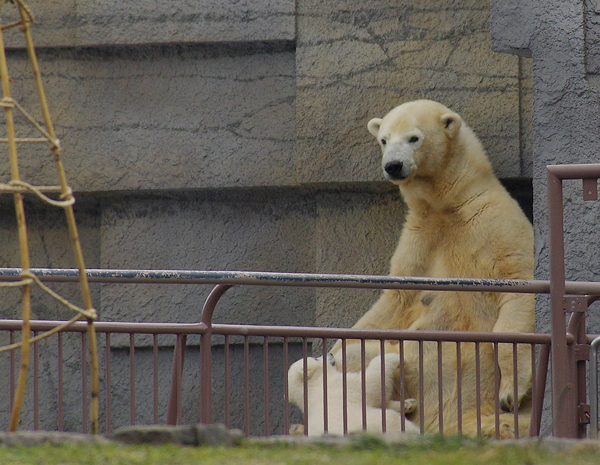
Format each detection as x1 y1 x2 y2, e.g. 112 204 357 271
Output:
331 100 534 437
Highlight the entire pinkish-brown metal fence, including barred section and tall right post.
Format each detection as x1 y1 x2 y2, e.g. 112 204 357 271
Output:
0 165 600 437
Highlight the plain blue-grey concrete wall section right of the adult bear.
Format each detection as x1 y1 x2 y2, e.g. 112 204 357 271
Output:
492 0 600 432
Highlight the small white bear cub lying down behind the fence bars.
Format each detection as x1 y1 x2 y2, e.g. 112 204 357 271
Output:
288 353 419 436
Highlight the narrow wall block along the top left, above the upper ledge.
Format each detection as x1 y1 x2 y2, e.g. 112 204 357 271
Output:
3 0 295 47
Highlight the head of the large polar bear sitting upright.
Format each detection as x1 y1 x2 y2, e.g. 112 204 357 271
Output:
367 100 464 185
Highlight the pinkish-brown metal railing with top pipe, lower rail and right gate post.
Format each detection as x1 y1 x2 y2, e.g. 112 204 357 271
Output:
0 165 600 437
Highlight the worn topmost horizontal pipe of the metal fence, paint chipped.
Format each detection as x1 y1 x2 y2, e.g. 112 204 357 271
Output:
0 268 600 295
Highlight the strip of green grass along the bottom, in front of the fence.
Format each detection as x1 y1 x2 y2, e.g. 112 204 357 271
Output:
0 437 600 465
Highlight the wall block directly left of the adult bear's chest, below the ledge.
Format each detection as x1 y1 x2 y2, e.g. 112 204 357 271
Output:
315 185 405 328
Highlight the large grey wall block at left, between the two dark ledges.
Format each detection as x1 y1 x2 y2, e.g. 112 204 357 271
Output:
0 45 295 192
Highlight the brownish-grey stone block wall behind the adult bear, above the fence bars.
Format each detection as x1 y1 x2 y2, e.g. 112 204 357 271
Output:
0 0 533 434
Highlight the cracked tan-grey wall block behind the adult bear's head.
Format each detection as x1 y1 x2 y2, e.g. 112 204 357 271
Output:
296 0 528 182
